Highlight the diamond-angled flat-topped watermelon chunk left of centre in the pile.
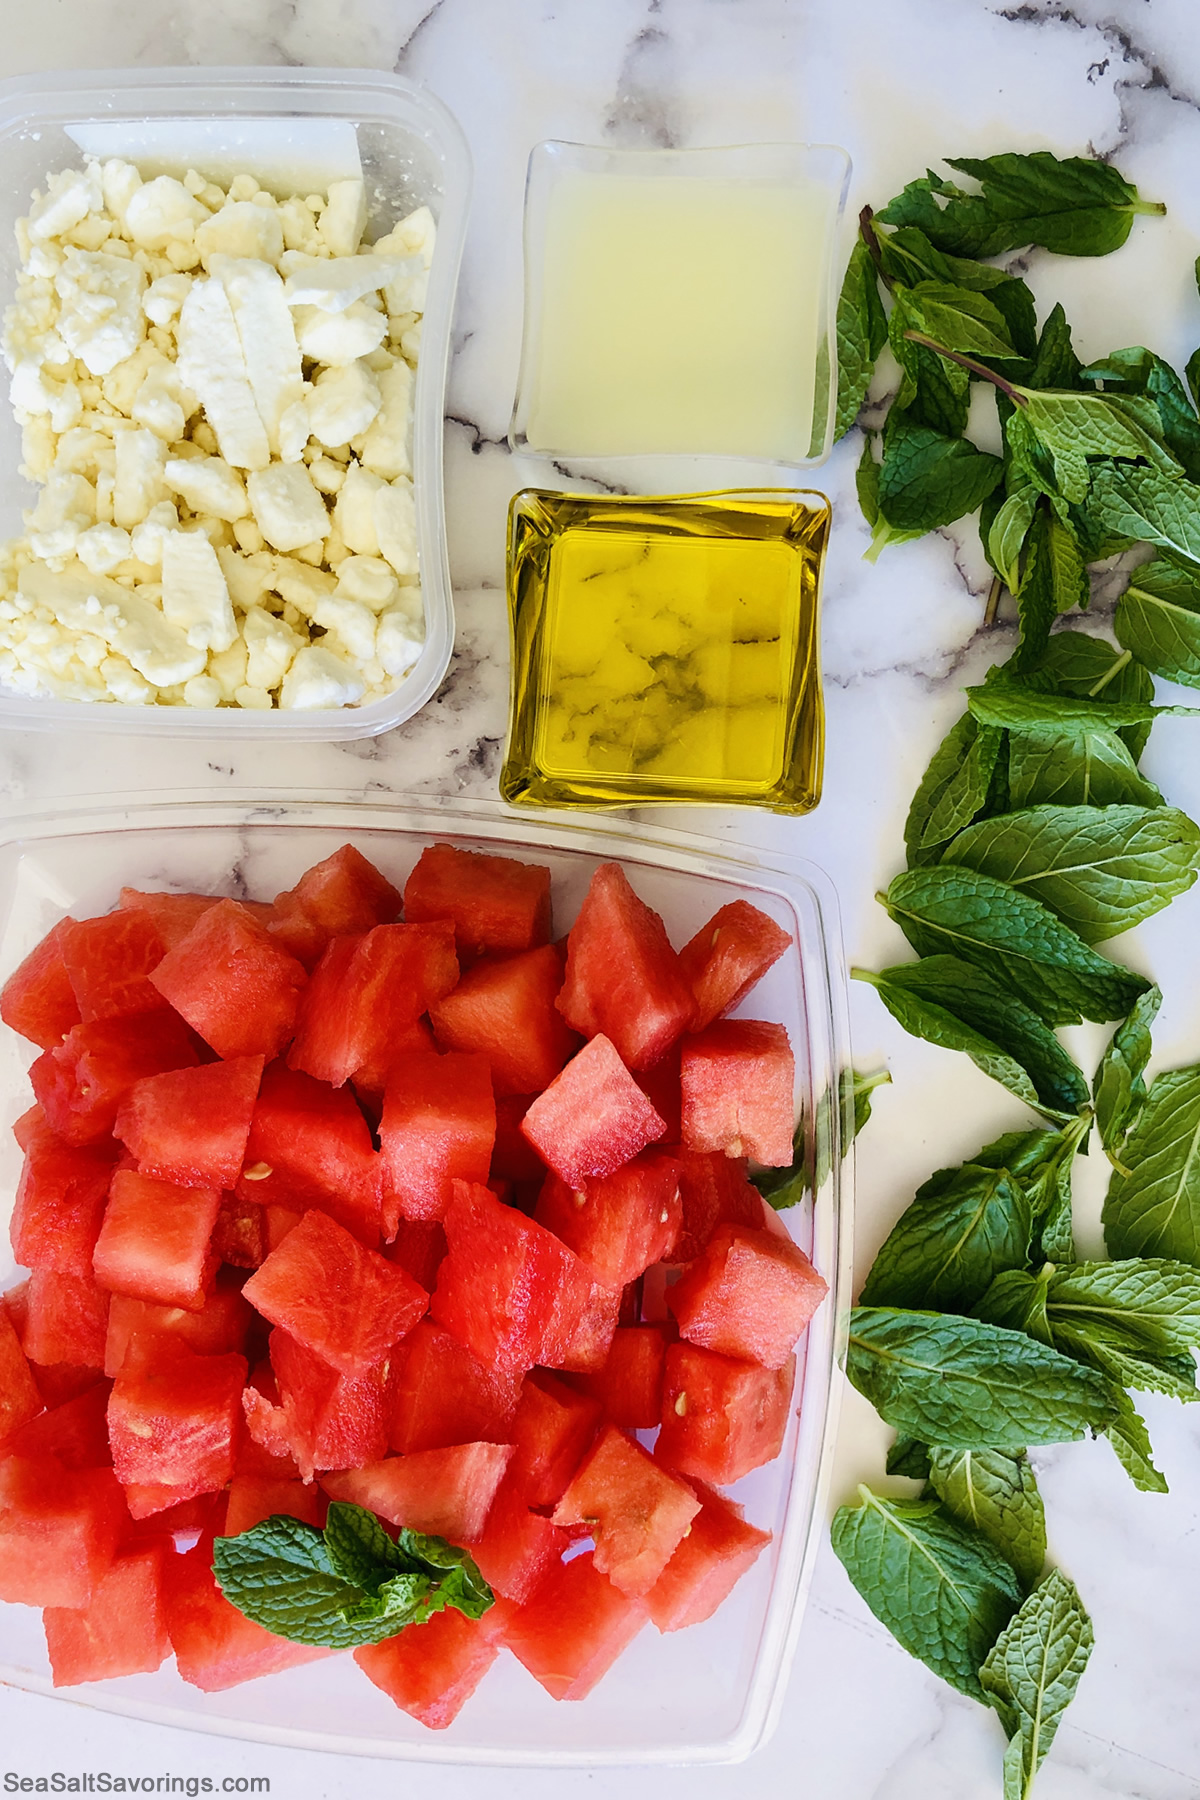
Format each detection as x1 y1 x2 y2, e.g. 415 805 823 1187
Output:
243 1211 428 1375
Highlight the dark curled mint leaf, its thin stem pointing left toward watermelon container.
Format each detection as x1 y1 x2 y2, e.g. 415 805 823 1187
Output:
851 957 1088 1118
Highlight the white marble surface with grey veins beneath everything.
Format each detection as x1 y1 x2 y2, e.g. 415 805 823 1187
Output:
0 0 1200 1800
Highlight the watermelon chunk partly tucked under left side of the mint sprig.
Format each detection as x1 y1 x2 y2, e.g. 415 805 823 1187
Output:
162 1534 331 1694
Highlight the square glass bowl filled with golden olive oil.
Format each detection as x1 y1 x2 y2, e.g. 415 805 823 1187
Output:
500 488 829 814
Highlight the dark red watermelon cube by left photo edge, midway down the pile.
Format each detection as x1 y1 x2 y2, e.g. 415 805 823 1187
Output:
9 1125 113 1276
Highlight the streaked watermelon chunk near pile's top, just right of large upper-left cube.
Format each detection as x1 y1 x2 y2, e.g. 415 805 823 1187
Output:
288 920 459 1087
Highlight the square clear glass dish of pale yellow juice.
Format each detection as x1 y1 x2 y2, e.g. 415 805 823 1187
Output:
509 142 849 468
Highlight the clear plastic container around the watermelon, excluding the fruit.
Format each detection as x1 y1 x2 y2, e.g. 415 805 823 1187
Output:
0 794 851 1766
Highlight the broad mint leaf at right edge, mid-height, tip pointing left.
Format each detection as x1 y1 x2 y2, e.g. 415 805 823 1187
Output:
943 806 1200 943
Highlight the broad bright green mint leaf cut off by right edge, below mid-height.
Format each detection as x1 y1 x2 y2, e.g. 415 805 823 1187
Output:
1103 1064 1200 1264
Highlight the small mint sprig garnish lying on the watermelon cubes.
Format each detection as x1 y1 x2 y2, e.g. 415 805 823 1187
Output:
212 1501 495 1651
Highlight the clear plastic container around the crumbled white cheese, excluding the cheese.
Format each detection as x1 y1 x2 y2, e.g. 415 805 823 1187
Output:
0 68 471 742
